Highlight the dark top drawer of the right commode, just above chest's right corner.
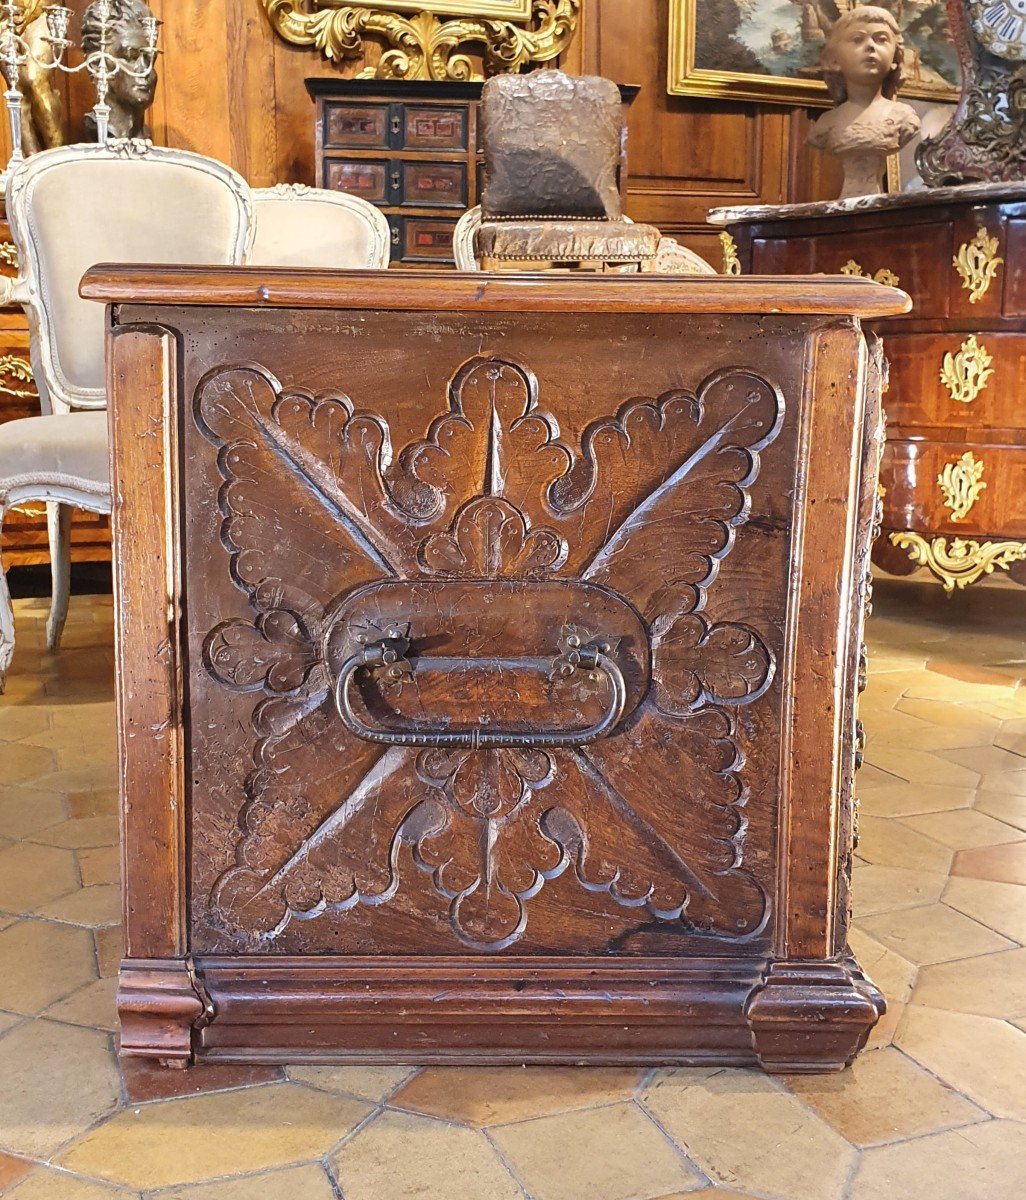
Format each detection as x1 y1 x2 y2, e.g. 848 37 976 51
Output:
751 221 958 323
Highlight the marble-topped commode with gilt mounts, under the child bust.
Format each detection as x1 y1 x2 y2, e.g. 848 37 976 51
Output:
712 184 1026 590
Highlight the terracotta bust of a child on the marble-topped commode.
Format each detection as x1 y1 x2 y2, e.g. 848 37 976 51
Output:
809 5 919 200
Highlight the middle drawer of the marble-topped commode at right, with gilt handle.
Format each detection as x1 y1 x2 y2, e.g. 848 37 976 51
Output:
884 331 1026 443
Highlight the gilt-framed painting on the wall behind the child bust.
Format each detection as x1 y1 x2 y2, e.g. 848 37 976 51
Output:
667 0 959 107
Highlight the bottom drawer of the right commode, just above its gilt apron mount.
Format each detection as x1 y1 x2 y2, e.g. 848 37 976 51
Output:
880 438 1026 538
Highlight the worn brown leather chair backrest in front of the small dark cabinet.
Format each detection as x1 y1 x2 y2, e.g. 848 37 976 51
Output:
481 71 624 221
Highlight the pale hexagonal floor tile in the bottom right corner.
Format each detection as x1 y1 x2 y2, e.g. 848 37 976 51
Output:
848 1121 1026 1200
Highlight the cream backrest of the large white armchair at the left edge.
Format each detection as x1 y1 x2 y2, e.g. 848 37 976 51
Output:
7 140 253 412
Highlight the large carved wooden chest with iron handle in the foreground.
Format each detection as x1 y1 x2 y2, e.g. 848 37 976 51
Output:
84 269 907 1070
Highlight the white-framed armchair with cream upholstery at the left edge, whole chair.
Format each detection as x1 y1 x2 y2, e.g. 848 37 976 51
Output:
0 140 253 690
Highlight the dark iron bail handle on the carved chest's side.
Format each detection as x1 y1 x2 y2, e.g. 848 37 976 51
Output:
335 625 626 750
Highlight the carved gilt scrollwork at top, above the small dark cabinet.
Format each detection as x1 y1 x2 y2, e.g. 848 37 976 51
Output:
262 0 581 82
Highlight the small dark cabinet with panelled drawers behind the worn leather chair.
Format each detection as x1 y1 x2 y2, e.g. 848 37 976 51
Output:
306 78 638 266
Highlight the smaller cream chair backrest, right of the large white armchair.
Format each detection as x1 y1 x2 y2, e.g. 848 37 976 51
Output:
246 184 390 270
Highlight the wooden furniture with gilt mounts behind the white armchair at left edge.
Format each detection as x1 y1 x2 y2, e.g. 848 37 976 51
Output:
0 200 110 570
